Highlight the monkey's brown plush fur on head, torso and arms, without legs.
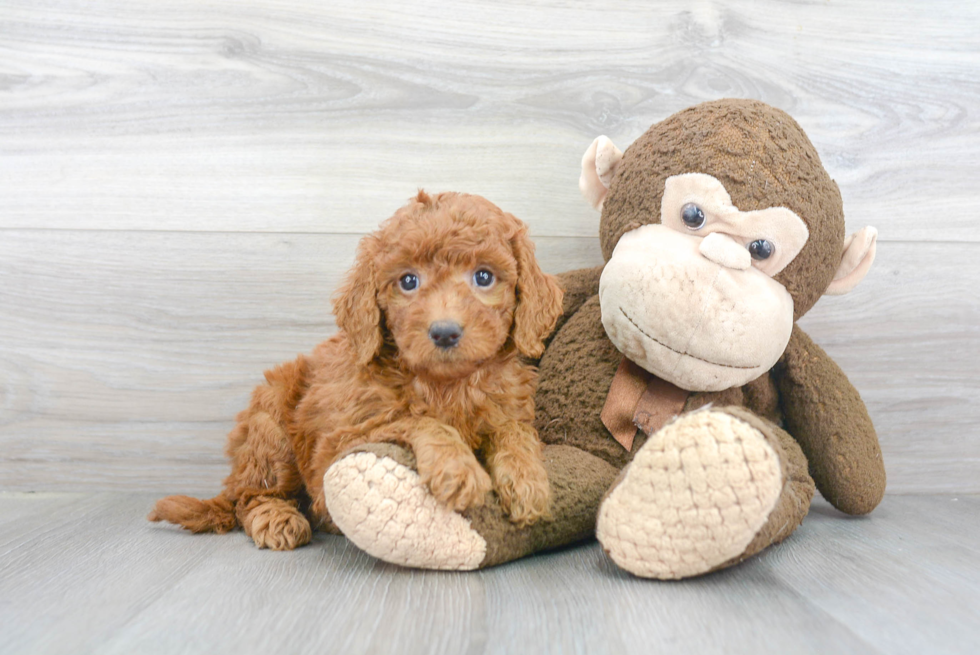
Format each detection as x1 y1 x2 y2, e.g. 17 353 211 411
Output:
535 99 885 522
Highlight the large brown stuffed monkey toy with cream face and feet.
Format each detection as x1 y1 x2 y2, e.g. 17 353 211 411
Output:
324 100 885 579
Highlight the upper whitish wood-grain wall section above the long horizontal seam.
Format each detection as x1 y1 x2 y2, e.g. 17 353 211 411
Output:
0 0 980 241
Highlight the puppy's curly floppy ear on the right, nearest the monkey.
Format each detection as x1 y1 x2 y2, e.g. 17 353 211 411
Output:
511 218 562 358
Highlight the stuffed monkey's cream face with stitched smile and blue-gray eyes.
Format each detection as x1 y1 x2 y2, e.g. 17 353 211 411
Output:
599 173 809 391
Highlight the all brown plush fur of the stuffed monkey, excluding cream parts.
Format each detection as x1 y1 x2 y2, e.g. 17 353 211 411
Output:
284 100 885 567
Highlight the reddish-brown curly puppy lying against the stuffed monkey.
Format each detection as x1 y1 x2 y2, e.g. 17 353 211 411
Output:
148 191 562 550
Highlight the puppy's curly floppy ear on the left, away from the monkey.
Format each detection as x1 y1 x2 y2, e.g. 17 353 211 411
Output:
333 234 383 366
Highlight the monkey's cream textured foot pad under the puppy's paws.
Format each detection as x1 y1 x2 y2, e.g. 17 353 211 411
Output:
323 452 487 571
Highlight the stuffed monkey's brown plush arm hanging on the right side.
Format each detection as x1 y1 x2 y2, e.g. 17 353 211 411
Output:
773 325 885 514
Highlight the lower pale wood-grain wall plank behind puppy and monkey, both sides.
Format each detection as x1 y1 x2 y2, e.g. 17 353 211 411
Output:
0 230 980 494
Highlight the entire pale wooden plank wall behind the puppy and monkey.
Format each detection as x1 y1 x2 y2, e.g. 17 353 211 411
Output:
0 0 980 493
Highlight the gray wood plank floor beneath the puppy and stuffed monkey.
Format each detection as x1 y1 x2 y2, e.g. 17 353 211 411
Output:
0 493 980 655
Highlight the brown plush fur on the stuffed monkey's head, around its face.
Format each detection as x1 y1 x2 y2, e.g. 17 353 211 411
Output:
599 99 844 319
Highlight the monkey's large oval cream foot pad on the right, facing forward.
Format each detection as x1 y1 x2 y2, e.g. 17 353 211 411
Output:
596 410 783 579
